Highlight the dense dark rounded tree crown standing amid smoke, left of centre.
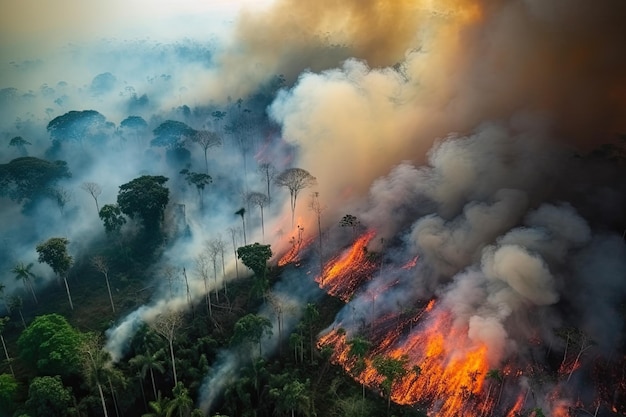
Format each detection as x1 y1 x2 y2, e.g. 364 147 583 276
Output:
117 175 169 232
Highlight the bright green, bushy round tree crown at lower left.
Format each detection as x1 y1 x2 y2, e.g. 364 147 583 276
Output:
17 314 83 376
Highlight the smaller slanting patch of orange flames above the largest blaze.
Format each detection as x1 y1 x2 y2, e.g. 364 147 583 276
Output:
316 230 376 301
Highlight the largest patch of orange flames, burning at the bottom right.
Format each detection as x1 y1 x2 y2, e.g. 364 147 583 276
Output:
319 302 504 417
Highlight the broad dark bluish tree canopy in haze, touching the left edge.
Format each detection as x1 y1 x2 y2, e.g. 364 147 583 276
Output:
0 156 72 203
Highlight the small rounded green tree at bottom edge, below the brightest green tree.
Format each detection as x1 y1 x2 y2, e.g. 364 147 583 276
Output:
25 375 72 417
